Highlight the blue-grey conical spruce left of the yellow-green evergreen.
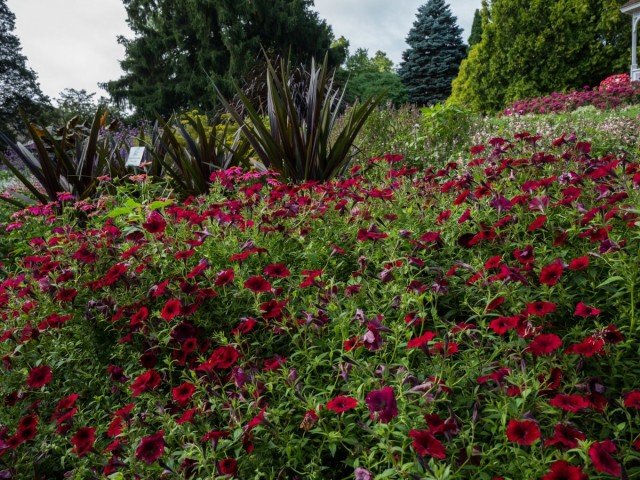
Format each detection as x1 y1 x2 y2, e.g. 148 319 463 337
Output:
398 0 467 105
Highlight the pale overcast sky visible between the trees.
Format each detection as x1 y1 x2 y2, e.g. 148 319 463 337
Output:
7 0 481 98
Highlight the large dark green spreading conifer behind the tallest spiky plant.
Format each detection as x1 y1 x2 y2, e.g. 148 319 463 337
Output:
105 0 345 115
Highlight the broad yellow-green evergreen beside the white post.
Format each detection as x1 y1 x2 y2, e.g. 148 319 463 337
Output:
450 0 631 112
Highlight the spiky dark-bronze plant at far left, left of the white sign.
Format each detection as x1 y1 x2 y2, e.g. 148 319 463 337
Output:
0 108 125 206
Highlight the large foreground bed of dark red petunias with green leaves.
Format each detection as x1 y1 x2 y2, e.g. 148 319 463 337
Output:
0 133 640 480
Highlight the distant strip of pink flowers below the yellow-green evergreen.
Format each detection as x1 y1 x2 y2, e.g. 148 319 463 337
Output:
503 73 640 116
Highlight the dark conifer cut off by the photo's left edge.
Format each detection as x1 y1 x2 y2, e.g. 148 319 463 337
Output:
0 0 49 135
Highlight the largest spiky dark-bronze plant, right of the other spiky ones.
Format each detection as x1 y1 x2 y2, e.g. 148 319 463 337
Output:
219 56 382 181
